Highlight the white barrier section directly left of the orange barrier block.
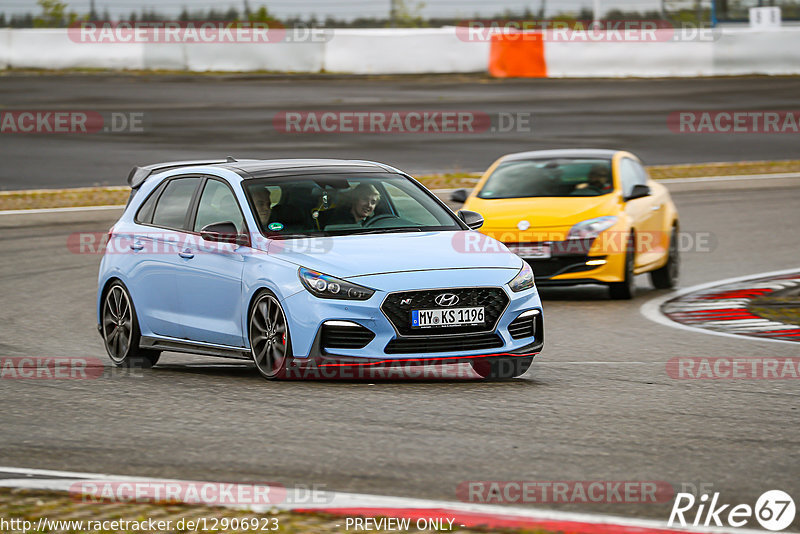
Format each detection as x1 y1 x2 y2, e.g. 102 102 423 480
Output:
325 28 489 74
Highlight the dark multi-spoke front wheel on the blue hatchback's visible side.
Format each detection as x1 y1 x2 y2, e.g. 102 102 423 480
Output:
247 291 292 380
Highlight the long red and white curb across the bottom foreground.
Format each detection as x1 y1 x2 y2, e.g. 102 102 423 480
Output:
0 467 776 534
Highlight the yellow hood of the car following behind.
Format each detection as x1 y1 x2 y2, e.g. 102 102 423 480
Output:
464 193 620 230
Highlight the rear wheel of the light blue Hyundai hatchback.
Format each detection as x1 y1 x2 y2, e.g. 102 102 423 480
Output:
100 282 161 369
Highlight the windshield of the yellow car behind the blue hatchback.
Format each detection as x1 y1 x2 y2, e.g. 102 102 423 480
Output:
478 159 614 199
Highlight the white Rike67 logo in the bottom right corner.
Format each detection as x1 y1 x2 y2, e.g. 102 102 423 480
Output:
667 490 795 531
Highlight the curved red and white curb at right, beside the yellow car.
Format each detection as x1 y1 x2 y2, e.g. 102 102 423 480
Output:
641 269 800 343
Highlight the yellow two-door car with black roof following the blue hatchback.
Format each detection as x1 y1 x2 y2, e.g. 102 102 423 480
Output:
451 150 680 299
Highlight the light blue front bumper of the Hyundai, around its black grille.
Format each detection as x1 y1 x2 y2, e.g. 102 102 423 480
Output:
283 270 544 365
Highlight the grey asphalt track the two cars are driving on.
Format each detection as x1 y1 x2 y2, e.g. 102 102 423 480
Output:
0 177 800 528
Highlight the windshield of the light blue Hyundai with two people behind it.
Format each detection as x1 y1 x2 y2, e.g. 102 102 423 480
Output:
243 173 464 238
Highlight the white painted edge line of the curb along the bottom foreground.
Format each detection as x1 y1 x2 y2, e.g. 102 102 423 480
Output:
0 467 780 534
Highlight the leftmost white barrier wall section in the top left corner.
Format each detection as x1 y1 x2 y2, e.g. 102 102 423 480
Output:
8 28 144 70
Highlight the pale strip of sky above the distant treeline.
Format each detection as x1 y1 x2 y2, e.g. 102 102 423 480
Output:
0 0 672 19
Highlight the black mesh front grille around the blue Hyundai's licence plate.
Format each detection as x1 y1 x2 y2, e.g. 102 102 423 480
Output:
381 287 508 337
